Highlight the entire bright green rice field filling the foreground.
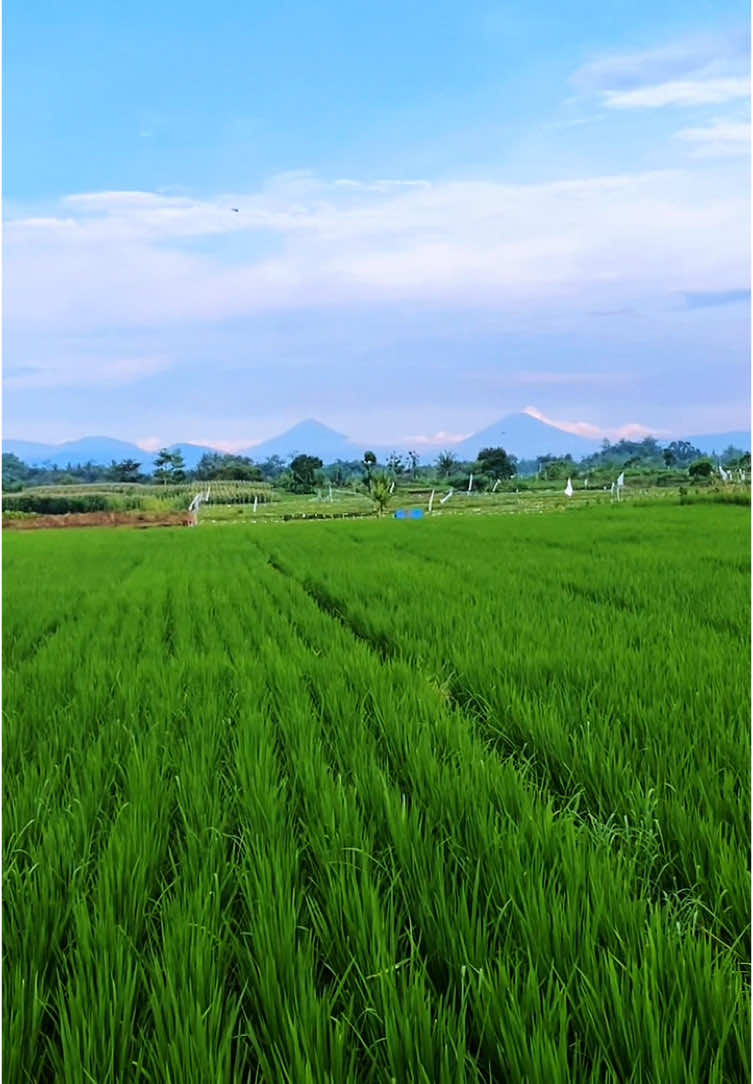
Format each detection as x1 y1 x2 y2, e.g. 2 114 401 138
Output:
2 502 751 1084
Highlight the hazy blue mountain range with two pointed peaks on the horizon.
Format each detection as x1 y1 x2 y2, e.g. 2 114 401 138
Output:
2 414 751 470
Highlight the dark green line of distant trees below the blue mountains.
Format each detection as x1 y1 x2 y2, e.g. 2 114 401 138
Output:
2 437 751 492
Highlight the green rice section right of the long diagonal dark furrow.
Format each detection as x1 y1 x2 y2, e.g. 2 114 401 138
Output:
264 508 750 959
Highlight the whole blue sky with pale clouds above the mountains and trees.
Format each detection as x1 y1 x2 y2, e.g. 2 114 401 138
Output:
2 0 750 449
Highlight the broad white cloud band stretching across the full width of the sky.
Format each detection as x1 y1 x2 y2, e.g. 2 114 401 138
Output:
4 170 749 370
